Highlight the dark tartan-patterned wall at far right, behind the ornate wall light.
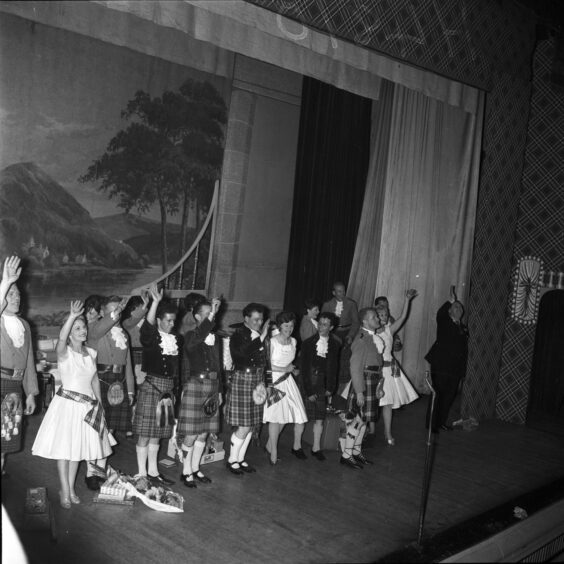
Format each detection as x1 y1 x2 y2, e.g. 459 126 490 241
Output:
496 38 564 423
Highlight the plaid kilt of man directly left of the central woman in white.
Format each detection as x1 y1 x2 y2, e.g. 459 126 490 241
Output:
225 369 264 427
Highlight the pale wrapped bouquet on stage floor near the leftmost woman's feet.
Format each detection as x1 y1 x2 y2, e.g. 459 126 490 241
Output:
94 466 184 513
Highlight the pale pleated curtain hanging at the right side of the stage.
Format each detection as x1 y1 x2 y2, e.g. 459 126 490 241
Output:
349 84 483 392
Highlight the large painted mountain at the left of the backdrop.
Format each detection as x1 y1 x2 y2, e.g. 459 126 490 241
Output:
0 162 140 268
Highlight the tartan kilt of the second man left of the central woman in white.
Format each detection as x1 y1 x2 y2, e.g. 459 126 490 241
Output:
176 378 219 438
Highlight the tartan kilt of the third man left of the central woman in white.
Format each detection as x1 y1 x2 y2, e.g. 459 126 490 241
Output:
133 374 174 439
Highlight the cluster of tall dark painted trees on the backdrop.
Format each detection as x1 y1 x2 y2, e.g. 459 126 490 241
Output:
79 79 227 273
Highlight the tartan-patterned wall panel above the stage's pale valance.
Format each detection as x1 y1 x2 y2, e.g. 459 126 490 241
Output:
247 0 534 90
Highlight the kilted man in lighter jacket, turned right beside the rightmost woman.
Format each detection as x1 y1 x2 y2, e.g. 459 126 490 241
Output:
340 307 384 469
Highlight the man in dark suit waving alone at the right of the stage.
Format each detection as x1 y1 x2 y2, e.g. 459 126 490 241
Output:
425 286 468 433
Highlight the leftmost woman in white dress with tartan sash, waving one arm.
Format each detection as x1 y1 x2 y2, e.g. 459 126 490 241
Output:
31 301 116 509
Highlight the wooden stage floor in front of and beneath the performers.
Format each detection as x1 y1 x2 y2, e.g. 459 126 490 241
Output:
2 398 564 564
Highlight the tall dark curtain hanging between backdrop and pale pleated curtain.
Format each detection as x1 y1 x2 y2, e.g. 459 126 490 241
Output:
284 77 372 314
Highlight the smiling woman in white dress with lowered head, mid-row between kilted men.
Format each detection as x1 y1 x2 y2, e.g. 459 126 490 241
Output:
263 311 307 466
